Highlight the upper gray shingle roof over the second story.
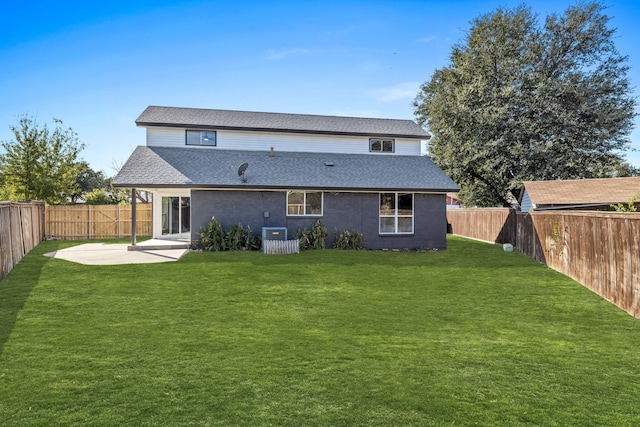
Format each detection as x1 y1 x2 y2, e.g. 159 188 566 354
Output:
136 106 429 139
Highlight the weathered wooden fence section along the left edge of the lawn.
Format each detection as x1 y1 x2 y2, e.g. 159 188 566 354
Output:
0 202 45 280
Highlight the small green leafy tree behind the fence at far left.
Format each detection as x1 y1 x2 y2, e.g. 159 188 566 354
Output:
0 116 84 204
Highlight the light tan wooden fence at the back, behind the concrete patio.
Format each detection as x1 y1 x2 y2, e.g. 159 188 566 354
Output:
45 204 152 240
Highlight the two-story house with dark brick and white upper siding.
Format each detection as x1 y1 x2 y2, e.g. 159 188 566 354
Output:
113 106 459 249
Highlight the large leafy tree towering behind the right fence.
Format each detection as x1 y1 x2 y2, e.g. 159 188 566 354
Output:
414 2 635 206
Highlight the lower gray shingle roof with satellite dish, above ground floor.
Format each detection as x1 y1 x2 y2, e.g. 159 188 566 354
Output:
113 146 459 192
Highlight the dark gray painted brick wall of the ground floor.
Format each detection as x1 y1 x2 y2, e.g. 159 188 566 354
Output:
191 190 447 249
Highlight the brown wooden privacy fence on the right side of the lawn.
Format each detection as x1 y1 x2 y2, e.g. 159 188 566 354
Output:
447 209 640 318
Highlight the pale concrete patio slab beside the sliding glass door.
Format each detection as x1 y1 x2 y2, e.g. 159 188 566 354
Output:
44 243 189 265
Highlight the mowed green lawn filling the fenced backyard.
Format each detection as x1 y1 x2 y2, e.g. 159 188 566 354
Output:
0 238 640 426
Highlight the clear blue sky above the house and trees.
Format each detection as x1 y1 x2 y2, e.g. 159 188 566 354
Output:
0 0 640 176
